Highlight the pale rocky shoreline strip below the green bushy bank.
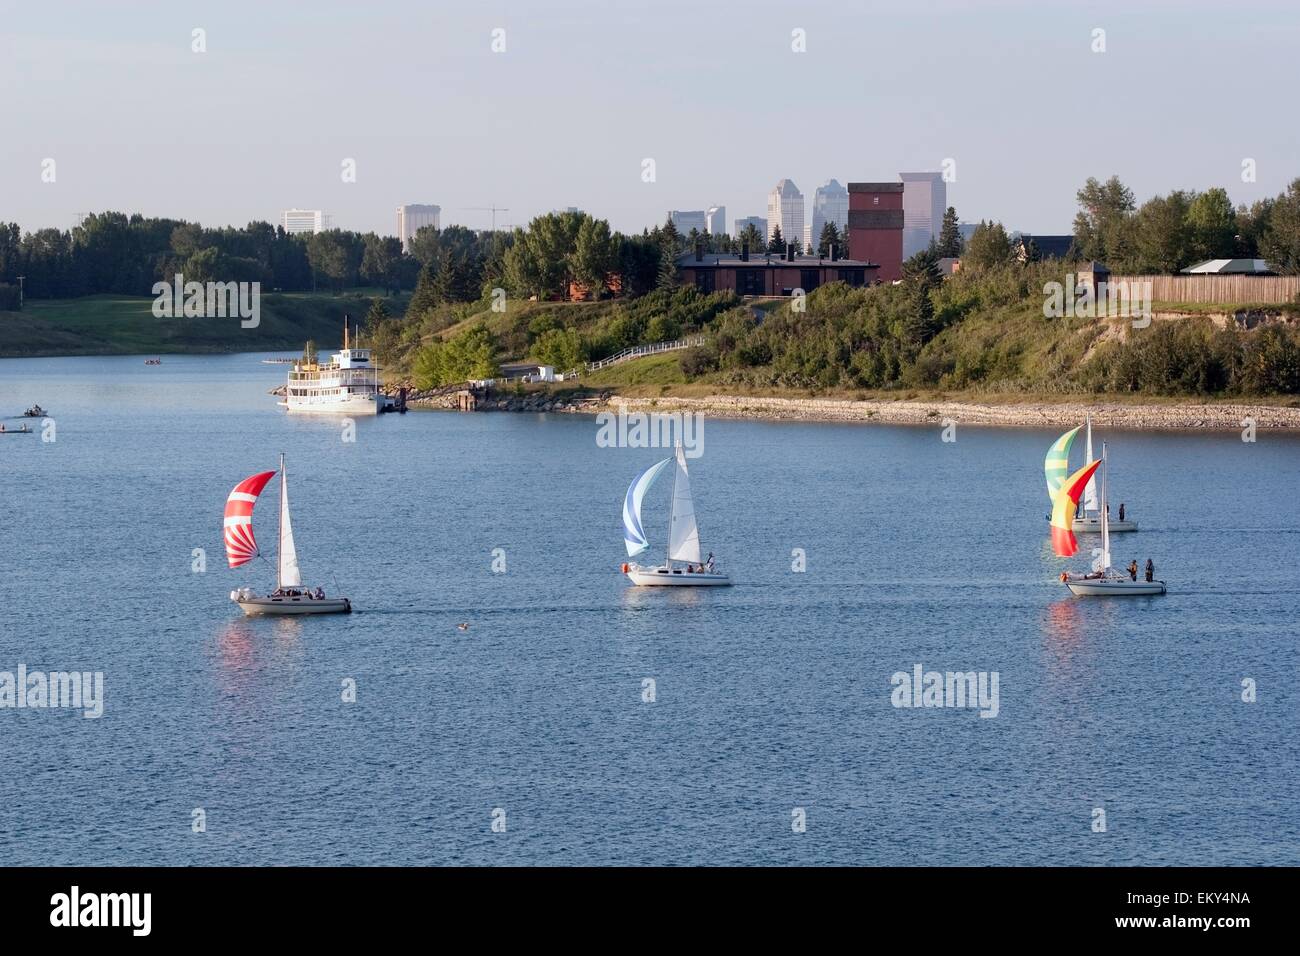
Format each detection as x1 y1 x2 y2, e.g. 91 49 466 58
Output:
390 388 1300 431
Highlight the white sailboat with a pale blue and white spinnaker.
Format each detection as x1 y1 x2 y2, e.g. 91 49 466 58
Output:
623 445 731 588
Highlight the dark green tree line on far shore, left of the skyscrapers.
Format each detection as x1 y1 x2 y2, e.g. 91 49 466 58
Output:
0 212 680 307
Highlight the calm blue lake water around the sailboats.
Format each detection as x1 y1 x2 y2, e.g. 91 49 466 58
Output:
0 355 1300 865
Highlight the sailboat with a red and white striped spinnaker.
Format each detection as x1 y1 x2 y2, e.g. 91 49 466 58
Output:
225 455 352 615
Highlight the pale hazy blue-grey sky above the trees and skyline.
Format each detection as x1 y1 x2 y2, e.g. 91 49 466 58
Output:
0 0 1300 233
